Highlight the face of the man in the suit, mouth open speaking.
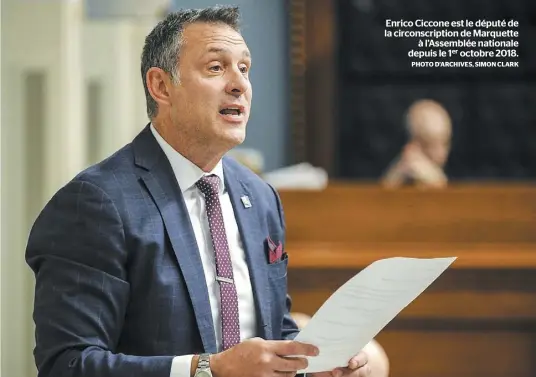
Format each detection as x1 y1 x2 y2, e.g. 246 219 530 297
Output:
170 23 252 149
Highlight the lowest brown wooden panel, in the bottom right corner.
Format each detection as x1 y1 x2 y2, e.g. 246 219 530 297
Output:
377 329 536 377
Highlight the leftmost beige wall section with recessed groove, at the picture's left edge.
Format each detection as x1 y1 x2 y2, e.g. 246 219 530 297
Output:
1 0 84 376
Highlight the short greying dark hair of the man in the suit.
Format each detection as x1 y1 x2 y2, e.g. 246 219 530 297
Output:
141 6 240 119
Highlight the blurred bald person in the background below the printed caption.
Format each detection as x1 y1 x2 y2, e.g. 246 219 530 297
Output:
381 99 452 188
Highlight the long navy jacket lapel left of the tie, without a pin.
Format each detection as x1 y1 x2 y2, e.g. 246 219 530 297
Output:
133 127 217 353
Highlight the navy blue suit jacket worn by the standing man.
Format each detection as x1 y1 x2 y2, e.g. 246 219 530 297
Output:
26 127 298 377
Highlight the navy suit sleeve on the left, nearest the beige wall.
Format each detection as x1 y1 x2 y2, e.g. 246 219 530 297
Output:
26 180 172 377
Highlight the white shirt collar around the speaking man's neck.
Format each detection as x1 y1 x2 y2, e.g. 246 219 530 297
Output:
150 123 225 195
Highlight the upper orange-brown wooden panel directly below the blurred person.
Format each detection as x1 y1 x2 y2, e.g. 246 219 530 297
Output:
281 183 536 243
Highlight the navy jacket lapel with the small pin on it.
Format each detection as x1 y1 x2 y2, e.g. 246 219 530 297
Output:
223 159 272 339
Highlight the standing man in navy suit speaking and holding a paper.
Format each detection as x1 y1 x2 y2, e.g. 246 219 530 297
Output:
26 7 369 377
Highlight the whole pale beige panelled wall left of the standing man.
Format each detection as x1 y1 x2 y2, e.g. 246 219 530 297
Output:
0 0 155 377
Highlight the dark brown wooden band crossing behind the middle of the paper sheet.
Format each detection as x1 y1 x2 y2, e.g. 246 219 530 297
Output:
288 268 536 326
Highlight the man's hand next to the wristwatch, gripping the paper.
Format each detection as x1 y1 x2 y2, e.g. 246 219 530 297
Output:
210 338 318 377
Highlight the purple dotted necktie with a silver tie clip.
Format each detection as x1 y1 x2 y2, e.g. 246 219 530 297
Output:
196 175 240 350
